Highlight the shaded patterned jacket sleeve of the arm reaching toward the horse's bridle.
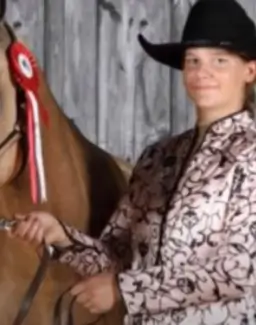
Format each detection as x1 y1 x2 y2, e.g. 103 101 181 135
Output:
58 145 156 276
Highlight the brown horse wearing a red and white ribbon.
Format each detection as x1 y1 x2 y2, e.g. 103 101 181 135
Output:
0 4 130 325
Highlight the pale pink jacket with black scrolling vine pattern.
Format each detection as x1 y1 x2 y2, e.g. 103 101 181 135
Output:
60 111 256 325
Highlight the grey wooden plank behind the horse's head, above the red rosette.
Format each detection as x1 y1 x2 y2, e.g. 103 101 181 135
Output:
6 0 44 67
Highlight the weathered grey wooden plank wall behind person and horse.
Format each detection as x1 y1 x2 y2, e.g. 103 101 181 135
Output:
4 0 256 162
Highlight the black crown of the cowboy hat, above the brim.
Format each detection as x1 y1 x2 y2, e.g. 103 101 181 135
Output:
182 0 256 42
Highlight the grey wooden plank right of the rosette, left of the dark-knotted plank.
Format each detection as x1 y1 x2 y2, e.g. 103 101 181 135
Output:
63 0 97 141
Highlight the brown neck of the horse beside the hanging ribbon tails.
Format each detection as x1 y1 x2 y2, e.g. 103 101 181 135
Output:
0 72 90 229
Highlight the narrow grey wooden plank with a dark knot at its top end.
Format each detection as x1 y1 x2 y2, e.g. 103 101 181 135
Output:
98 0 123 155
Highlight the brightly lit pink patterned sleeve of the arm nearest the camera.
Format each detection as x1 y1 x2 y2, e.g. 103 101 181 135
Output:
118 161 256 315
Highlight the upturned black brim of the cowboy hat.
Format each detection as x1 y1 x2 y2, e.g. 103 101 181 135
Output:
138 34 256 70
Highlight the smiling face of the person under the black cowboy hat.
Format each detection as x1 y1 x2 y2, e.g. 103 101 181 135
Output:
183 48 256 114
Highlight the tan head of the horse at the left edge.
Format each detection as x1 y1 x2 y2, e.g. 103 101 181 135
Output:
0 9 24 186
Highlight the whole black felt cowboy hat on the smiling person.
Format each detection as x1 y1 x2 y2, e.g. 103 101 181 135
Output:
138 0 256 70
